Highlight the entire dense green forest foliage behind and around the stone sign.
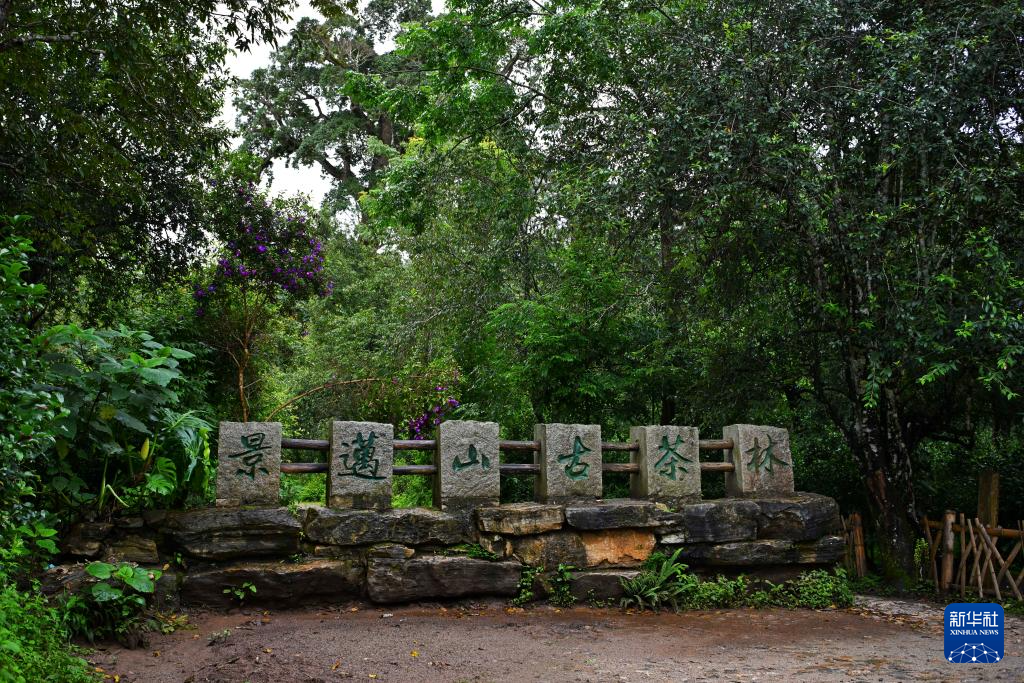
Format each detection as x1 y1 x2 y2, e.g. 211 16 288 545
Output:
0 0 1024 680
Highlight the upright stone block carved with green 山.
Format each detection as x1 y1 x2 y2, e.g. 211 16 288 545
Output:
434 420 502 510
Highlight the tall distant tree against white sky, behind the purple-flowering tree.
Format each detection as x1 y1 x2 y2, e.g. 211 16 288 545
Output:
234 0 430 212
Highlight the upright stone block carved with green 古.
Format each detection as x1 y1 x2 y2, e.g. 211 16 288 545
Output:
534 424 601 503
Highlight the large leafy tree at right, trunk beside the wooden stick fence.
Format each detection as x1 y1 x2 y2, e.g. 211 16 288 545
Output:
349 0 1024 572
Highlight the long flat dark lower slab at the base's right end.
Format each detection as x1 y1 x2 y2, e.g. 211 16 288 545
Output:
667 537 844 566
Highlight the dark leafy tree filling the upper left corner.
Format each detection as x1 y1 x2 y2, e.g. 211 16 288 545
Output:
0 0 290 317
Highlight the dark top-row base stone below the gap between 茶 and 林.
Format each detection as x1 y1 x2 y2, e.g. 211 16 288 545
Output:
654 499 760 544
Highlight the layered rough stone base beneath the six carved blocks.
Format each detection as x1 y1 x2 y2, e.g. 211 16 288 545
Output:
54 493 843 605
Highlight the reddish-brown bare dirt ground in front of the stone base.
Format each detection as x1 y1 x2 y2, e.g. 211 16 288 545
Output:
92 599 1024 683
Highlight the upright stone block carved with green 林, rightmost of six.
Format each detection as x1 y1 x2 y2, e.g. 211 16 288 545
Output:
722 425 793 496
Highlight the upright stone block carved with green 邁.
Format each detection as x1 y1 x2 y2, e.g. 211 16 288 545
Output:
327 422 394 510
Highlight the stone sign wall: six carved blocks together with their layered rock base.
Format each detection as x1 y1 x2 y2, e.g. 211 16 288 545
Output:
44 421 843 605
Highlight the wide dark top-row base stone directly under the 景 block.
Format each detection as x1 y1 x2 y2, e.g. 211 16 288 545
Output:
161 508 302 560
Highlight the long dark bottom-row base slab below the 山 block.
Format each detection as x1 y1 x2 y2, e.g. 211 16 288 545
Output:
367 556 522 603
